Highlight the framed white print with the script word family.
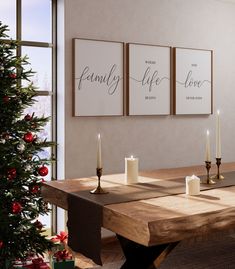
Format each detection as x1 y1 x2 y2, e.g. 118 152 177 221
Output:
74 38 124 116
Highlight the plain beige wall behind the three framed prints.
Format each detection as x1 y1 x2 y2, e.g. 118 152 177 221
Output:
59 0 235 178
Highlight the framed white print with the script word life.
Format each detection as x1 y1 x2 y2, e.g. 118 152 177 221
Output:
127 43 171 115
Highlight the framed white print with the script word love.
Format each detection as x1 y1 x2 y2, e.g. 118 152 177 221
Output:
173 48 213 115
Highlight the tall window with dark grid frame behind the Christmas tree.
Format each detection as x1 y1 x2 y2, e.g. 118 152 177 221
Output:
0 0 56 231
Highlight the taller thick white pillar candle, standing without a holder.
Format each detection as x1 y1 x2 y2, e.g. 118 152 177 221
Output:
125 156 139 184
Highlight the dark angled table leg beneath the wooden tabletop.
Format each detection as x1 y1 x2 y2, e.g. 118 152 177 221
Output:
117 232 178 269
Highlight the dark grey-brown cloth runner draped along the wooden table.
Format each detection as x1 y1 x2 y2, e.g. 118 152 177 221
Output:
67 172 235 265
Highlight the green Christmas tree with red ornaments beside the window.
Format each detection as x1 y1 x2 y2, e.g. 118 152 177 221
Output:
0 22 54 269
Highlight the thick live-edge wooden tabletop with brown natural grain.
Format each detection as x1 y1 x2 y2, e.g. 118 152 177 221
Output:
42 163 235 246
